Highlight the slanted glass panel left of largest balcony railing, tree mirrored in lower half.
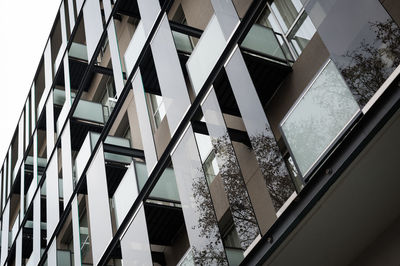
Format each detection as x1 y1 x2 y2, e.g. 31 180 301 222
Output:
225 49 294 211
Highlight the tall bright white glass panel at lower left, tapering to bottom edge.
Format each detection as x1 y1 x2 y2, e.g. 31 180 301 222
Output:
86 145 112 265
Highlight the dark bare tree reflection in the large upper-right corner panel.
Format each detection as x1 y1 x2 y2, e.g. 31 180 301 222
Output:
340 19 400 106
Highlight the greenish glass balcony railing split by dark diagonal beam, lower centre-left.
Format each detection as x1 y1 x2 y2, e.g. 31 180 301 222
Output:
135 162 180 202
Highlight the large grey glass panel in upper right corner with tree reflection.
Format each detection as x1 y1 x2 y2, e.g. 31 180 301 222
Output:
305 0 400 107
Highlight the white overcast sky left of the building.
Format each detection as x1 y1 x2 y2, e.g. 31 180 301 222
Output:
0 0 61 164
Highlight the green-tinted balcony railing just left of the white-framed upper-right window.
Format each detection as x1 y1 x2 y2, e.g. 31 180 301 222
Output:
241 24 286 61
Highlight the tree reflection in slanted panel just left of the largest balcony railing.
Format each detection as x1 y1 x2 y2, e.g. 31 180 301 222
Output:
250 126 294 211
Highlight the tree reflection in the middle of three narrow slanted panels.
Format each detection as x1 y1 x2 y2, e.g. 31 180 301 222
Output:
211 133 260 250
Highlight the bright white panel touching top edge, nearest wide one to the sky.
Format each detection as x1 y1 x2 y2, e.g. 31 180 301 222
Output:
83 0 103 61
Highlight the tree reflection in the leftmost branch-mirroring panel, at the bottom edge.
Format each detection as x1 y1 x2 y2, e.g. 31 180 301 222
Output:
192 169 227 265
